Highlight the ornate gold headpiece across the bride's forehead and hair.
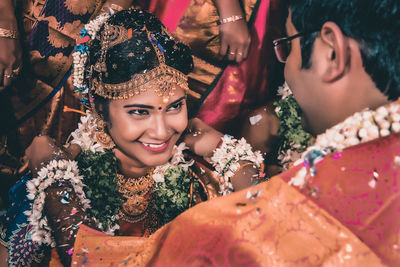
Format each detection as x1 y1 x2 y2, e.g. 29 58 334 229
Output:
91 25 189 99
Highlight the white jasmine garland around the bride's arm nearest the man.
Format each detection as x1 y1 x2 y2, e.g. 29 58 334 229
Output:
211 135 264 195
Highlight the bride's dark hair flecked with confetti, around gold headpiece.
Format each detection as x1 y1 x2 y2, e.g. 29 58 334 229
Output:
85 9 193 120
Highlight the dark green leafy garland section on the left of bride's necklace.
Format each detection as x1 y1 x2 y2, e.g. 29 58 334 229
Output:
77 151 122 231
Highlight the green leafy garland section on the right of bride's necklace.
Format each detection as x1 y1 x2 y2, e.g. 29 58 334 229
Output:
154 166 200 224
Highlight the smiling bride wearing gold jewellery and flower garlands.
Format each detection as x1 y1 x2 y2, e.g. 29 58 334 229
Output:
0 10 263 266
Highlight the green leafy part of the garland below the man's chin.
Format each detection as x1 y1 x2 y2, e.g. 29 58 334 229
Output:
274 95 313 153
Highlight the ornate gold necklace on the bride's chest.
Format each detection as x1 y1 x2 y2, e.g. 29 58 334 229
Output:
117 168 155 223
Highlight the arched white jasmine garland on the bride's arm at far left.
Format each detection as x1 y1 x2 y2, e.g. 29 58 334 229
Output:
25 160 90 247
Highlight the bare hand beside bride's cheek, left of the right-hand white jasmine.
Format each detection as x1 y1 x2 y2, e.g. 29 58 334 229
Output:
183 118 223 160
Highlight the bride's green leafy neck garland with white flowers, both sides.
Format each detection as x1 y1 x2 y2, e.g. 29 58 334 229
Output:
71 111 194 230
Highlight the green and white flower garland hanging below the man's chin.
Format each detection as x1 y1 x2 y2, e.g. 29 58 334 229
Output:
274 83 314 170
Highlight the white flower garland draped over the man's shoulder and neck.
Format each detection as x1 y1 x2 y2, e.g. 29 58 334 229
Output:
289 100 400 193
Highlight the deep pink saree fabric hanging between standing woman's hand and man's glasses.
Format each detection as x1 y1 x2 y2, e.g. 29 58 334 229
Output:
197 0 282 133
